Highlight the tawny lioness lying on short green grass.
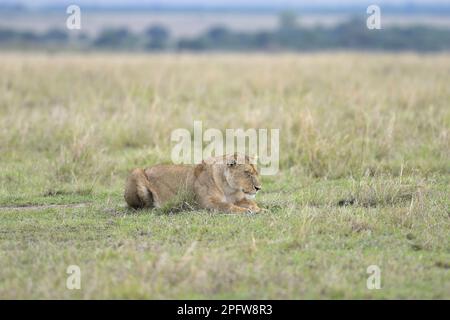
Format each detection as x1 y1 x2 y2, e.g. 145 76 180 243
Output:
125 154 261 213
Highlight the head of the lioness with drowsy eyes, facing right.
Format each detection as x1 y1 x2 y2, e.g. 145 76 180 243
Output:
225 155 261 199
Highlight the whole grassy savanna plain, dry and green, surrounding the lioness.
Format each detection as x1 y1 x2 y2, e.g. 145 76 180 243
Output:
0 53 450 299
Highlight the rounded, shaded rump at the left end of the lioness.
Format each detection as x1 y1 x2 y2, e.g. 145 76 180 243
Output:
124 168 153 209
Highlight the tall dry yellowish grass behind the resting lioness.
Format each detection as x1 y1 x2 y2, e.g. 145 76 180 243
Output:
0 53 450 192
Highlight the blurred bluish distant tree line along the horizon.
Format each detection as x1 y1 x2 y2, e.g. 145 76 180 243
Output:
0 13 450 51
